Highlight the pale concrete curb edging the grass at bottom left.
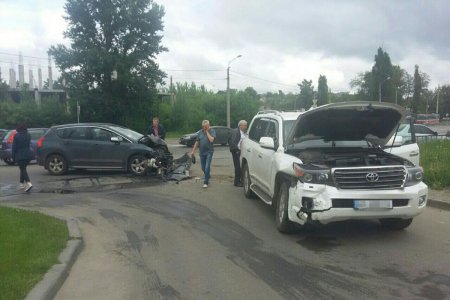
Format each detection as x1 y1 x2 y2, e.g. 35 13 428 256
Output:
25 216 84 300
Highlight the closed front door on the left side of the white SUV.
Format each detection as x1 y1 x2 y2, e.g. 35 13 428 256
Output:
256 119 279 194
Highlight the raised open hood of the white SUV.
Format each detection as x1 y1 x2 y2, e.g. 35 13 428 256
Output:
286 102 406 148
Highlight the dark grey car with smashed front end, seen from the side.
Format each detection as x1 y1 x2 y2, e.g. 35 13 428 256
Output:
37 123 172 175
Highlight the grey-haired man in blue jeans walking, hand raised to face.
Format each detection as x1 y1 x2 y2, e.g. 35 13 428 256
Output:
191 120 216 188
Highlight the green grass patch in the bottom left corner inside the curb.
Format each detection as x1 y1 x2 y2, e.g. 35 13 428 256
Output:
0 206 69 299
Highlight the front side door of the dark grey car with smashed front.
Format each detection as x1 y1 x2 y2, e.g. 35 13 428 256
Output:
89 127 130 169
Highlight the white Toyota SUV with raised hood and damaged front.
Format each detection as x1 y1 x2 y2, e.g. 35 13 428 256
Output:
241 102 428 232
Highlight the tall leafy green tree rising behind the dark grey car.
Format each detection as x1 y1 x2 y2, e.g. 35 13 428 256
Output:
49 0 166 131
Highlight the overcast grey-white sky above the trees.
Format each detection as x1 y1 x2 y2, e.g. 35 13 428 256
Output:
0 0 450 92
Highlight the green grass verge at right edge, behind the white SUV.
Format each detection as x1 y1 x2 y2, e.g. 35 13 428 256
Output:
419 140 450 189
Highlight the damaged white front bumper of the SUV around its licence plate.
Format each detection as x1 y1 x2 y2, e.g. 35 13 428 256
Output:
288 181 428 225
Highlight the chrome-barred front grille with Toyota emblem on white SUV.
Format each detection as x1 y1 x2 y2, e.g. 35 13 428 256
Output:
333 166 407 189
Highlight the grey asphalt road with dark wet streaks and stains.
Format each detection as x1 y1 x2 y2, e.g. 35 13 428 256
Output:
0 141 450 299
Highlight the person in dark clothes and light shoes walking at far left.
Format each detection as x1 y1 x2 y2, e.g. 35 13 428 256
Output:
12 123 34 192
